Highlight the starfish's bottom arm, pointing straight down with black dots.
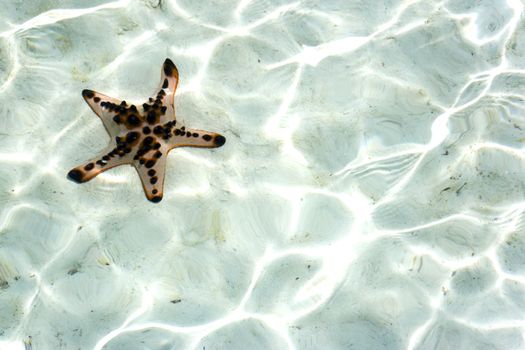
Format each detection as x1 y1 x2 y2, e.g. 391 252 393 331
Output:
133 148 168 203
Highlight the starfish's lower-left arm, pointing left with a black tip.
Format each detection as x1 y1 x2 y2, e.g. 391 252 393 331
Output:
67 145 132 183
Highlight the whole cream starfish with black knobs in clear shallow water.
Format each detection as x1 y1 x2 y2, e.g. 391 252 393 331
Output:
67 58 226 203
